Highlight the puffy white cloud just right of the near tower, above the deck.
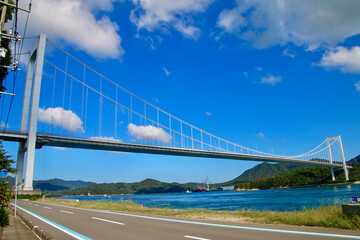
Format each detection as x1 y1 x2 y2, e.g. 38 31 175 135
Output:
38 107 84 133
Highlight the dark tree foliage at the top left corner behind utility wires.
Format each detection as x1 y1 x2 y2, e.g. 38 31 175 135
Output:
0 0 15 91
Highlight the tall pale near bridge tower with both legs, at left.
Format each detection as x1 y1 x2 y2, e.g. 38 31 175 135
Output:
16 33 46 191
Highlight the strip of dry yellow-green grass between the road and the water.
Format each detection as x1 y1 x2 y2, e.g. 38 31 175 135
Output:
39 199 360 230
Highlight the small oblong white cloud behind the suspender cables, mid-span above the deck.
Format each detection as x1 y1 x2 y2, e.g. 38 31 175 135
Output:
128 123 171 143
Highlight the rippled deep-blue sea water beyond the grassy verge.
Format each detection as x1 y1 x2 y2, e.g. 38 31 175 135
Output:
64 185 360 211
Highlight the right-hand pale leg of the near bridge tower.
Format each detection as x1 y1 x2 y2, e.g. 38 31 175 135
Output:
23 33 46 191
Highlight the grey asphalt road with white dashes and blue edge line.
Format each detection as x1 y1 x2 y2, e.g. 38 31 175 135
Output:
12 200 360 240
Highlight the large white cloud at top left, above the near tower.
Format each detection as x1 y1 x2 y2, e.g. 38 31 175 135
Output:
22 0 124 59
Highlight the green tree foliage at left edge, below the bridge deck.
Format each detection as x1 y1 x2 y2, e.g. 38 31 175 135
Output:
0 142 15 227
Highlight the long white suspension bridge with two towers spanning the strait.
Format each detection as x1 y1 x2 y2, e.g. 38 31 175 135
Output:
0 34 349 191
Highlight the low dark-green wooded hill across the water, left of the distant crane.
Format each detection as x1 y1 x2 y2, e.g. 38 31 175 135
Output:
64 178 191 195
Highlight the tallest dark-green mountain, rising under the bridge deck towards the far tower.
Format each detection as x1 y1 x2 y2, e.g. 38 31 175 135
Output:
216 162 305 186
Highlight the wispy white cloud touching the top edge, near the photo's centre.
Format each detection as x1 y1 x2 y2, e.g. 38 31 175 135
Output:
130 0 213 39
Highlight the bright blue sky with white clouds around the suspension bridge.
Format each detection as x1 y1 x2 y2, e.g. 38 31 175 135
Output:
1 0 360 183
